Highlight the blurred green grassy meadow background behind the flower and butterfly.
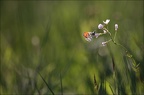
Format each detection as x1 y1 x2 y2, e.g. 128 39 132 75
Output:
0 0 144 95
